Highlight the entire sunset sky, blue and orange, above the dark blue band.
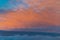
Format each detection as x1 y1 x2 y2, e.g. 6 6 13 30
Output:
0 0 60 30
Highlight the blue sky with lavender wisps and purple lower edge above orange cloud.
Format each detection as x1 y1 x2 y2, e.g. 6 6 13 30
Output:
0 0 29 13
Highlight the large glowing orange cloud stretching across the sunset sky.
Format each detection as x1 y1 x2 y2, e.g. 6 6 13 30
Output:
0 0 60 30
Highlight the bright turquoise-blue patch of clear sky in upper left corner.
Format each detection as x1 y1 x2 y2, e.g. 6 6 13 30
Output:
0 0 16 9
